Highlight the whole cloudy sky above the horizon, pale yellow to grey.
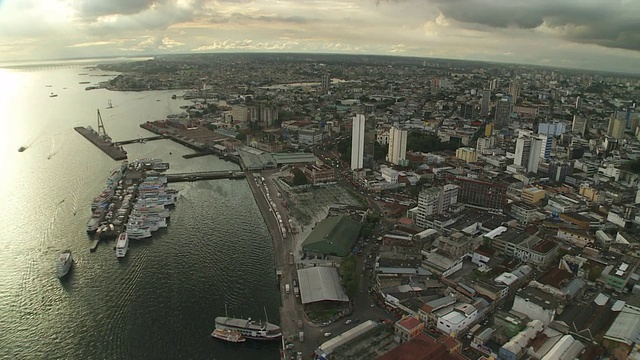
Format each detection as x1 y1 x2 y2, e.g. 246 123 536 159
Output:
0 0 640 73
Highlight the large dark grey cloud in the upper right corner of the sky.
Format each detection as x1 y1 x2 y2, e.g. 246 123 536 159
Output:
431 0 640 51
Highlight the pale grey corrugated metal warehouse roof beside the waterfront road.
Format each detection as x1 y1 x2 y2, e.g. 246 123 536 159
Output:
298 266 349 304
